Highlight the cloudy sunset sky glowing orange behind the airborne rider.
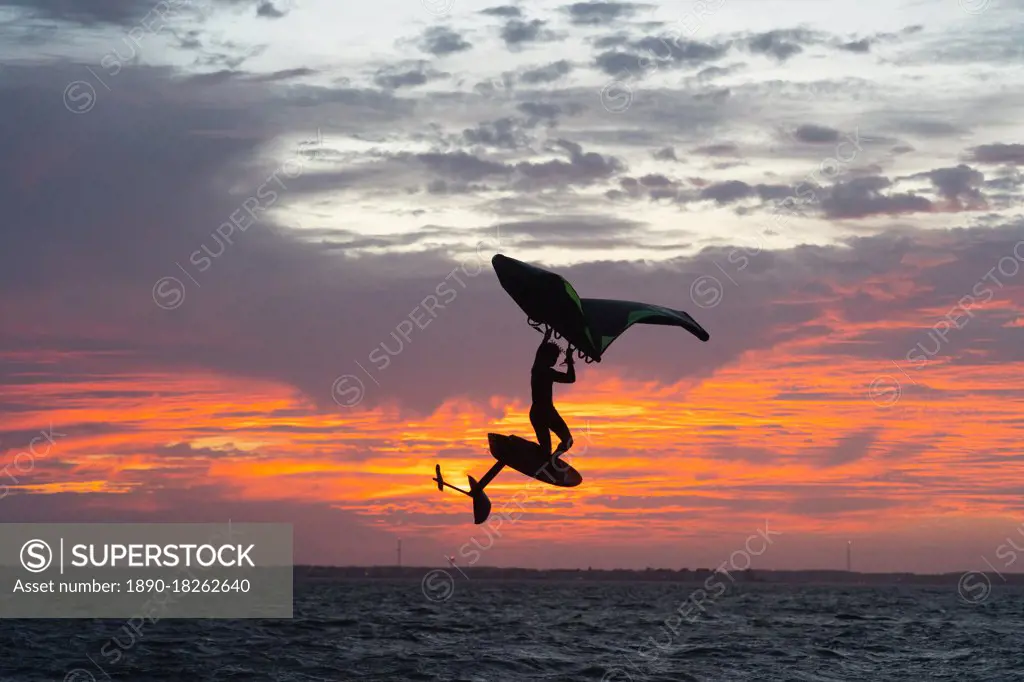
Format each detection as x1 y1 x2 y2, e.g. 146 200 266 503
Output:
0 0 1024 572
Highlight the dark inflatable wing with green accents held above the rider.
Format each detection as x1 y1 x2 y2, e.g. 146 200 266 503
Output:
490 254 711 363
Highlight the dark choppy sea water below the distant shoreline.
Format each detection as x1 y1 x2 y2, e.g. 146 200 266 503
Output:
0 577 1024 682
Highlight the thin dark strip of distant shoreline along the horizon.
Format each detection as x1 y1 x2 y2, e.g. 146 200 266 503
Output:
294 563 1024 588
